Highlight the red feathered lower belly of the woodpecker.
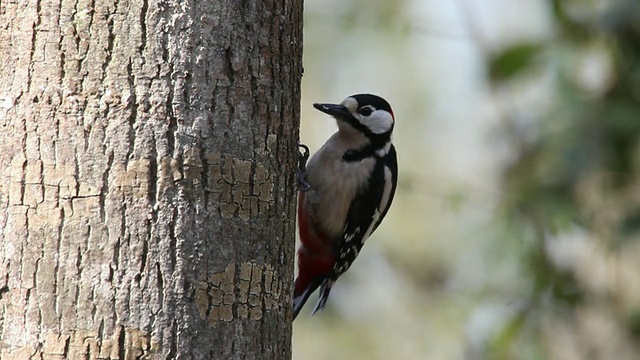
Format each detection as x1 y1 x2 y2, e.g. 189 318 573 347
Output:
294 192 335 297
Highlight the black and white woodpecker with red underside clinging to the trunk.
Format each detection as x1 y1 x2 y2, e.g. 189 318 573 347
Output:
293 94 398 319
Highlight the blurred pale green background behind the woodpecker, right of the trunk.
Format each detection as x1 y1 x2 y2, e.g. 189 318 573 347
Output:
294 0 640 360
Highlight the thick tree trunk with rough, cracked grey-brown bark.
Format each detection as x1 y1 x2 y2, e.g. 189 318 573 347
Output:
0 0 302 360
